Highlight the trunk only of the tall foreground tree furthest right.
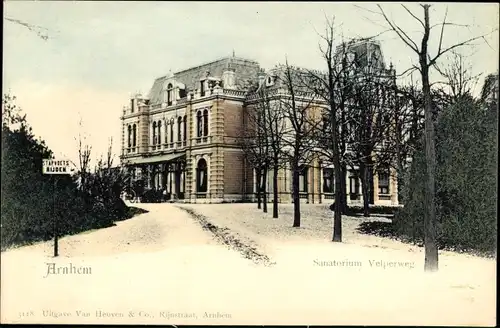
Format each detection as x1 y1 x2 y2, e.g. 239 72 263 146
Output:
420 5 438 272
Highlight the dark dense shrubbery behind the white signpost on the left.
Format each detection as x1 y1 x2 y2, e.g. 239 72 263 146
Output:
0 97 137 250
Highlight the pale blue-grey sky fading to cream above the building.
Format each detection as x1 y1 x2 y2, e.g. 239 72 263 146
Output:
2 1 499 168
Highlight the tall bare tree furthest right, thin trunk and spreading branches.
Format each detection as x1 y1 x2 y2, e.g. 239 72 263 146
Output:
376 4 494 271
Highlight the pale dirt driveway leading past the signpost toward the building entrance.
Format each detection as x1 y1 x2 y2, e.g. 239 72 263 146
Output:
0 204 216 257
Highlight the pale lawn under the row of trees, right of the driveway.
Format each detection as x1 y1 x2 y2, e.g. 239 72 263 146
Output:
179 204 404 252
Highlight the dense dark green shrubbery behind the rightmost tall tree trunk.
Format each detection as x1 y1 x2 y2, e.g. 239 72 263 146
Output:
394 98 498 252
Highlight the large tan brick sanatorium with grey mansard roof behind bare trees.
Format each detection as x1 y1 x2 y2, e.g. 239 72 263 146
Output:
121 43 398 205
